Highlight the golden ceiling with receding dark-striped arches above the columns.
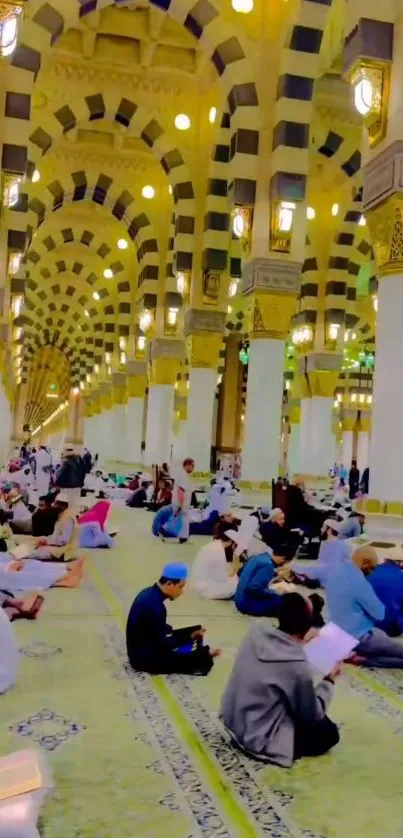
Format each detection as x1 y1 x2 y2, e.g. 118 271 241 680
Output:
0 0 378 423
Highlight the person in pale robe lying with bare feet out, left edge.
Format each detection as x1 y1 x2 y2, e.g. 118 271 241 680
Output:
0 553 86 596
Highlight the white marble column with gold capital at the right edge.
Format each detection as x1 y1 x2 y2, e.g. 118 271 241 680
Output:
363 140 403 502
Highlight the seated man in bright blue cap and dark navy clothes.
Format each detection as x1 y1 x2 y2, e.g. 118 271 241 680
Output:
126 562 220 675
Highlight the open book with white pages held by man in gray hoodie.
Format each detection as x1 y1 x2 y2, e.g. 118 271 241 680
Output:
304 623 359 676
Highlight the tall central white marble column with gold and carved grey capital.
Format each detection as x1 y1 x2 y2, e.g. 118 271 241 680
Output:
242 258 300 482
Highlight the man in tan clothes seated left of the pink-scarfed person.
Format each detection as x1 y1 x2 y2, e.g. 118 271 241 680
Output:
19 492 78 562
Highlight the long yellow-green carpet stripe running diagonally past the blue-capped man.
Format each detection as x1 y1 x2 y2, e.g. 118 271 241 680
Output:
87 563 260 838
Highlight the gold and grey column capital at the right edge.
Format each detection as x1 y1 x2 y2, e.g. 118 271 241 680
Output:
363 140 403 276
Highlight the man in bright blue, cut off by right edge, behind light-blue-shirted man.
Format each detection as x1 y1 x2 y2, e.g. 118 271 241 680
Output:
368 545 403 637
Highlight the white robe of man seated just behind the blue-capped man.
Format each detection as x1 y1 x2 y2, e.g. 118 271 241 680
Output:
190 540 238 599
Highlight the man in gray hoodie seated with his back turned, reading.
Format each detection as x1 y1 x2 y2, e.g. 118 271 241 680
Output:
220 593 340 768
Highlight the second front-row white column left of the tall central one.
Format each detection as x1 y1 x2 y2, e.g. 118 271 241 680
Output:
145 338 183 466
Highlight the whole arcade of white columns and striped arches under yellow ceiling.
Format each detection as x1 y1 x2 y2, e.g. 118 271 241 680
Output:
0 0 403 511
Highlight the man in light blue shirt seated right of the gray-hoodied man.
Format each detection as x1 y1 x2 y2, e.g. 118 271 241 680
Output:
326 545 403 669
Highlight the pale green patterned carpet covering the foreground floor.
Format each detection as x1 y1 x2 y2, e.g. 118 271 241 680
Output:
0 508 403 838
